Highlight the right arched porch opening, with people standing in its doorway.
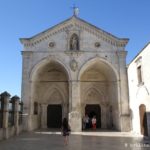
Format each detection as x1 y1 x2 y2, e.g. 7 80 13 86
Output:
79 58 120 130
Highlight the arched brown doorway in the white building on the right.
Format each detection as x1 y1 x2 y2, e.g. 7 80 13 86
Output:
139 104 148 136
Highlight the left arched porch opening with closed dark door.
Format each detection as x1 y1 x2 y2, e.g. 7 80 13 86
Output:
32 60 69 128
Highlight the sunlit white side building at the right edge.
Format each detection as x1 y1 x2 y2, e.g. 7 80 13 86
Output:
128 43 150 136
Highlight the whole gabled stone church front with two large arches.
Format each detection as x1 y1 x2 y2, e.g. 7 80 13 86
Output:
20 15 131 131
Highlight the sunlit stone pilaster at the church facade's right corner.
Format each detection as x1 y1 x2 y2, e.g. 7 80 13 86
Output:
117 51 130 131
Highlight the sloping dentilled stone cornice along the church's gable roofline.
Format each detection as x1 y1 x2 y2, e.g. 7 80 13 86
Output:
20 16 129 46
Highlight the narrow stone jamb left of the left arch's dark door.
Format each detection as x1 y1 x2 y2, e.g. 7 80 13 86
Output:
41 104 47 129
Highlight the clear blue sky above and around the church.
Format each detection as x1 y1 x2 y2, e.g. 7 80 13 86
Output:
0 0 150 96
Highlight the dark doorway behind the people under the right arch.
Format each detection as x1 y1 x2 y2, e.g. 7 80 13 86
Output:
85 104 101 128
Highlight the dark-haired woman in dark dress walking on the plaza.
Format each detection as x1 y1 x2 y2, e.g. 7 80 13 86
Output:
62 118 71 145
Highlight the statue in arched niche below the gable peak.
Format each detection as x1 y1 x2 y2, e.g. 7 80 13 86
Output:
70 34 79 50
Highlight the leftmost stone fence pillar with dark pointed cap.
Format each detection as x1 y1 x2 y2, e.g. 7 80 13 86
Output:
1 92 11 139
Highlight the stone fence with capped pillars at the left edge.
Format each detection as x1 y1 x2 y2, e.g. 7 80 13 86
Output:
0 92 23 140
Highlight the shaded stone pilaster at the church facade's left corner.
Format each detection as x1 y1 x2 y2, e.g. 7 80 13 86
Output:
21 51 33 131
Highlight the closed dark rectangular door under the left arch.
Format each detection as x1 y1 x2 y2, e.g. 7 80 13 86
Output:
47 105 62 128
